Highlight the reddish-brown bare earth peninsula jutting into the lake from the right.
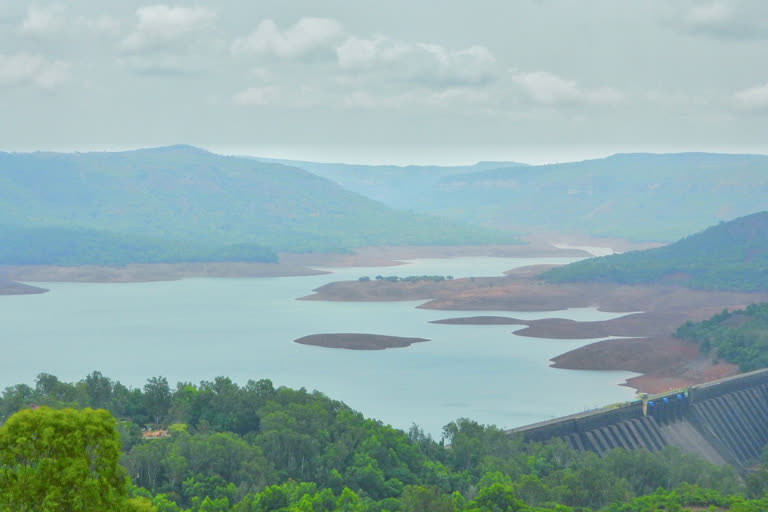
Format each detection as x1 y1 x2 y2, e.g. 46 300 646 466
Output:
304 268 768 393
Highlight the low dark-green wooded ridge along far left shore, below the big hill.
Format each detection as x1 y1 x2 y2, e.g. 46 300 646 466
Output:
0 226 277 265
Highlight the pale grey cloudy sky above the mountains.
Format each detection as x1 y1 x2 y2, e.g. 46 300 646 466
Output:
0 0 768 164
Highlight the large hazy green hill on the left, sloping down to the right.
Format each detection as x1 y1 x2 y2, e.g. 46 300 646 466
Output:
0 146 515 264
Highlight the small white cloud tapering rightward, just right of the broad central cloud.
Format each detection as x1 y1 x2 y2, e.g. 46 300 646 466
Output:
512 71 624 106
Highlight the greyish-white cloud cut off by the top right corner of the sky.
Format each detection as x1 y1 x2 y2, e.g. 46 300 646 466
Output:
677 0 768 39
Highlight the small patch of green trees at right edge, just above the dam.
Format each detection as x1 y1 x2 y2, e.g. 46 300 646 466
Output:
675 303 768 372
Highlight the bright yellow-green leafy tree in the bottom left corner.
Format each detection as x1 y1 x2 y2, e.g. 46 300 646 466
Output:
0 407 126 512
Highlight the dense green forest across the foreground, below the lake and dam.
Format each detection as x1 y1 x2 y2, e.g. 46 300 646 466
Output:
0 372 768 512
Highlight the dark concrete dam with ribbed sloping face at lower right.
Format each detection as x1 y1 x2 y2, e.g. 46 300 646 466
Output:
509 369 768 469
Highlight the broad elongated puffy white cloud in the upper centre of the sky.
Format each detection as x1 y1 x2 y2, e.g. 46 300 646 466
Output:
336 35 497 87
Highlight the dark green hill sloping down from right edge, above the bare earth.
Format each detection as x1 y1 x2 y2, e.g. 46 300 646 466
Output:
541 212 768 291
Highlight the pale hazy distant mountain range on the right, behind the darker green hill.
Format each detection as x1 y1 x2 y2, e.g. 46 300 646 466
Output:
274 153 768 241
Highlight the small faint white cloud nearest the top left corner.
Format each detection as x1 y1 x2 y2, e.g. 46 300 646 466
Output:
19 5 120 36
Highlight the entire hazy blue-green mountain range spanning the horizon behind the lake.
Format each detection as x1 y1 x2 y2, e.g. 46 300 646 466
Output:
6 145 768 264
